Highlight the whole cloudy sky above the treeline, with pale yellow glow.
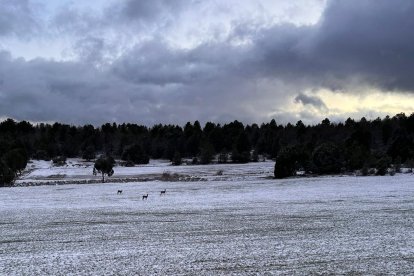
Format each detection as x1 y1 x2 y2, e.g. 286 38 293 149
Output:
0 0 414 126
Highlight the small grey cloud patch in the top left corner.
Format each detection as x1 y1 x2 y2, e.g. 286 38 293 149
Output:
0 0 39 38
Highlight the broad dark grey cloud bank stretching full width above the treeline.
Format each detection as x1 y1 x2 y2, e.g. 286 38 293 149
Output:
0 0 414 124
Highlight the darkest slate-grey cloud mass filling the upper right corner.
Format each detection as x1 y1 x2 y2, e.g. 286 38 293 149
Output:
309 0 414 90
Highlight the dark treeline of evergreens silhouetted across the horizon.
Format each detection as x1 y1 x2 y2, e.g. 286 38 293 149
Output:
0 113 414 185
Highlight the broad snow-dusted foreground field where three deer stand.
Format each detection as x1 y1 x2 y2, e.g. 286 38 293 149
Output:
0 162 414 275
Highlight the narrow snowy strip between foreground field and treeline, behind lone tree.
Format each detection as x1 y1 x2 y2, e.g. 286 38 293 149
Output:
16 159 274 186
